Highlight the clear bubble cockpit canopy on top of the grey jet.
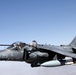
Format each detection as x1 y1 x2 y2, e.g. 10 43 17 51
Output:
7 42 26 50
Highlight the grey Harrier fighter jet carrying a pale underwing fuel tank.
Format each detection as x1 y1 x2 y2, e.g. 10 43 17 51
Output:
0 37 76 67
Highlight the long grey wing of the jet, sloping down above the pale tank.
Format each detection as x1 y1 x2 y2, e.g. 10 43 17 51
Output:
37 45 76 59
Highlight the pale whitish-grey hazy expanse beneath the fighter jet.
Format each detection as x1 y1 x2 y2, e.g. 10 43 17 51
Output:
0 61 76 75
